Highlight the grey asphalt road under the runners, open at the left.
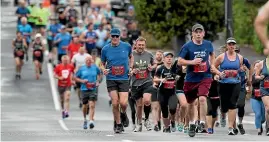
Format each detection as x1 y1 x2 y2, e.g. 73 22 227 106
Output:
1 3 268 142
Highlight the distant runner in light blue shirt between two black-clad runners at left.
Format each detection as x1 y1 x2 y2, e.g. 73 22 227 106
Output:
18 17 33 61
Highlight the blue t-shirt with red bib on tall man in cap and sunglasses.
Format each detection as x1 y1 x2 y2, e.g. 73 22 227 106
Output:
101 41 132 80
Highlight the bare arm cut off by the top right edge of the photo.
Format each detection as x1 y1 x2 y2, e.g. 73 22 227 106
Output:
254 1 269 45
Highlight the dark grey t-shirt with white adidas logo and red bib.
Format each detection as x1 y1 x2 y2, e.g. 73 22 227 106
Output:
131 51 154 86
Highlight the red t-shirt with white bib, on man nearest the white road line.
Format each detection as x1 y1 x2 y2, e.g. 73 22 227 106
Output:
54 64 74 87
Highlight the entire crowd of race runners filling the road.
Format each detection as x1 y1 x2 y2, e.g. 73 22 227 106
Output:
12 0 269 137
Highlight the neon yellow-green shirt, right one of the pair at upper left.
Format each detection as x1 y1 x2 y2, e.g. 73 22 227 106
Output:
36 8 50 25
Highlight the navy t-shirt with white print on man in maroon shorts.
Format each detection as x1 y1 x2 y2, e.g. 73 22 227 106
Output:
179 40 214 82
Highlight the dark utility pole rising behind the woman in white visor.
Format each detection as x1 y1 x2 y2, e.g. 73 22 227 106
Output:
225 0 233 38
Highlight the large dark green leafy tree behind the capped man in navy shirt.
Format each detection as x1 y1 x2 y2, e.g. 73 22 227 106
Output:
133 0 224 51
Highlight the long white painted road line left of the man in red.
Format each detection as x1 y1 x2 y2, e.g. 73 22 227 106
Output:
47 63 60 111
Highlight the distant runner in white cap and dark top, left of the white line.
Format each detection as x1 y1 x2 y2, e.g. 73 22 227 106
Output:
32 33 45 80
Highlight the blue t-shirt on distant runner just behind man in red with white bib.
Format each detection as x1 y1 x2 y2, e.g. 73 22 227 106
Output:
54 32 72 54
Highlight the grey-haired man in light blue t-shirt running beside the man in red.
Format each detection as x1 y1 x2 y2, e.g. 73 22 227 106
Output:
75 56 101 129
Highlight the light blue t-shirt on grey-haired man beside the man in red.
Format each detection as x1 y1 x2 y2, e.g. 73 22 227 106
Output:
76 64 100 91
